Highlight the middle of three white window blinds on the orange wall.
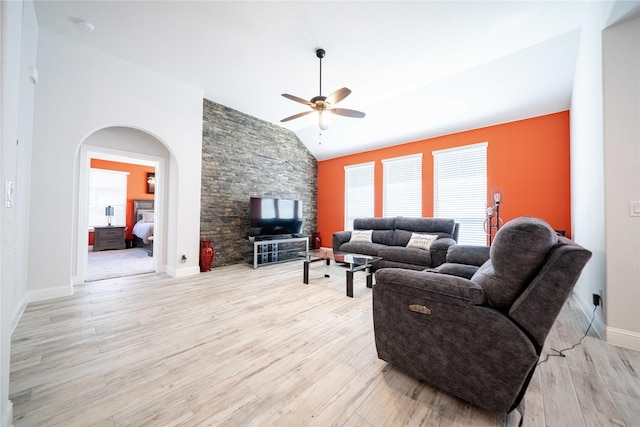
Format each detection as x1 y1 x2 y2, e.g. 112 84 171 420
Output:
382 153 422 217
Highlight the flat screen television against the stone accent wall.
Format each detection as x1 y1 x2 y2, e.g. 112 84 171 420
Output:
249 197 302 236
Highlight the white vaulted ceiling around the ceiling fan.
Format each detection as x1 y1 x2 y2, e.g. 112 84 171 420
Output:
35 0 637 160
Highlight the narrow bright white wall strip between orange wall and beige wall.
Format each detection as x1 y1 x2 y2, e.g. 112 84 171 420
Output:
571 0 605 337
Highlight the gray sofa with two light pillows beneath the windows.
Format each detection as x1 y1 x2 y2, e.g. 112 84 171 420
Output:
332 217 458 270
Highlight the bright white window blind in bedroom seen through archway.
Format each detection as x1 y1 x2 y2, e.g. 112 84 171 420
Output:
89 168 129 227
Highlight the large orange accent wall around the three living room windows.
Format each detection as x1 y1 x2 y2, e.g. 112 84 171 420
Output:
318 111 571 247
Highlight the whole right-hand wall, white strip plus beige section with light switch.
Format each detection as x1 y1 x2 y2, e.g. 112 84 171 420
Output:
571 2 640 350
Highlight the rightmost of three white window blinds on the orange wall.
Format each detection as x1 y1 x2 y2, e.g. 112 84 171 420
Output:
433 142 488 246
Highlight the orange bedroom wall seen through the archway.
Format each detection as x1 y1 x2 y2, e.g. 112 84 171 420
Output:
89 159 155 246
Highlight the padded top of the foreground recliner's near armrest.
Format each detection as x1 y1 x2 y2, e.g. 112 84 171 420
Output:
374 268 486 306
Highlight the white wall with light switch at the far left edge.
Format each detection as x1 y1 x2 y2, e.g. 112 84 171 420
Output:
0 1 38 427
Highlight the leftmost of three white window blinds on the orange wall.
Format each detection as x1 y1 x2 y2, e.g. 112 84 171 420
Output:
344 162 375 230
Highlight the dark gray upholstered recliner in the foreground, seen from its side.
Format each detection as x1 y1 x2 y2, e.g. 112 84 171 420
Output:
373 217 591 420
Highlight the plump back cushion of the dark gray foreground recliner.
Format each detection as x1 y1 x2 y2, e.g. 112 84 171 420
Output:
471 217 558 310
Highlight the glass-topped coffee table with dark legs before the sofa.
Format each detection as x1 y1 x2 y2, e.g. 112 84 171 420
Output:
302 249 382 298
